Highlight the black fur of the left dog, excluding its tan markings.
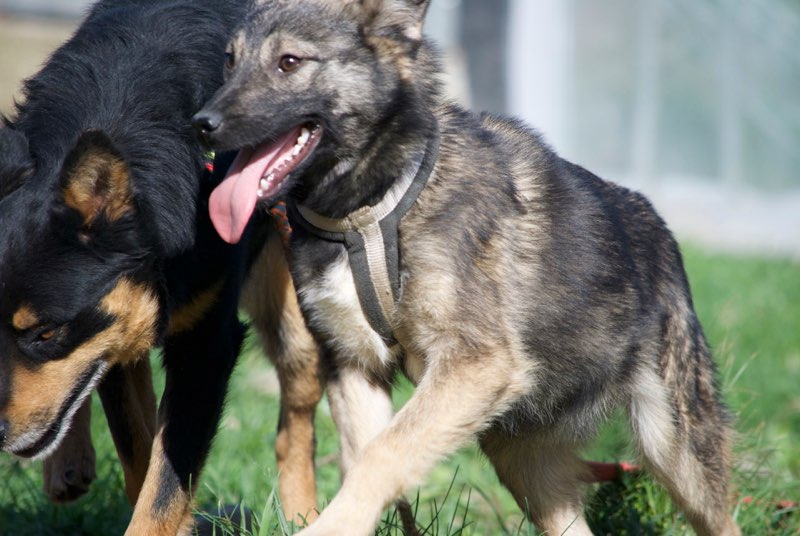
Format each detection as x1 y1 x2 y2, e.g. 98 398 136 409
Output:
0 0 255 528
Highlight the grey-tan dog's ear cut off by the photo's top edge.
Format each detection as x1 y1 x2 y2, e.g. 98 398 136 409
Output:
358 0 430 44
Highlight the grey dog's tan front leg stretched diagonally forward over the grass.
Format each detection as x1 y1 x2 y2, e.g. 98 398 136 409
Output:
300 352 529 536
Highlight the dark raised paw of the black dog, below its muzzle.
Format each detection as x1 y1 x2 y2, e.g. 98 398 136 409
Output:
43 435 97 503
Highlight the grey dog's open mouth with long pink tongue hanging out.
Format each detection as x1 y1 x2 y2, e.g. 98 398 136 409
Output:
209 123 322 244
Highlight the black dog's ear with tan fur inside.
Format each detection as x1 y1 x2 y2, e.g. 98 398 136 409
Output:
61 130 133 227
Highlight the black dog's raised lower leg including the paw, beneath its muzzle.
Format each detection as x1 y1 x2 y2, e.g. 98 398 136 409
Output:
43 397 96 503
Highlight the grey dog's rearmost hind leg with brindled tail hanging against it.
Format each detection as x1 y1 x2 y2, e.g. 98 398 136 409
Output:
629 278 739 535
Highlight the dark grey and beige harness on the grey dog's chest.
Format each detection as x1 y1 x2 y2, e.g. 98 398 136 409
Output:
287 128 439 346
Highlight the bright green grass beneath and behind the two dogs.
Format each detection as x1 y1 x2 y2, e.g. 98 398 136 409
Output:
0 248 800 536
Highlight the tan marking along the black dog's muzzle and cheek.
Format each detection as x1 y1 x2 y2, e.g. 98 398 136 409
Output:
5 279 158 437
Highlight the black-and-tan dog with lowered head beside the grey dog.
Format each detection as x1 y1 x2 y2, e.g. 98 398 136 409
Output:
0 0 256 535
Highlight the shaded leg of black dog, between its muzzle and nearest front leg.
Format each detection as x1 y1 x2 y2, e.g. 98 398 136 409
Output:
99 354 156 505
